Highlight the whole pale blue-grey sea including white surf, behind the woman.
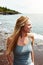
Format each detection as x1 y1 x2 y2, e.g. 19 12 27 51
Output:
0 14 43 49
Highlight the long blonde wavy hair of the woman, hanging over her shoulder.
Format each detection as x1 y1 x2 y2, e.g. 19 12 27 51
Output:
6 16 29 54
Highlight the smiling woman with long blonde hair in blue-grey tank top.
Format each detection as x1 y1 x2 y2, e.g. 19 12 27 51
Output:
6 16 34 65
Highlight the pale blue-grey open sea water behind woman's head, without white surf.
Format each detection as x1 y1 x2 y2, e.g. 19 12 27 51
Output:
0 14 43 34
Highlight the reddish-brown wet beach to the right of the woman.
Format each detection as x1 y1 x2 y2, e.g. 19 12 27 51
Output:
34 45 43 65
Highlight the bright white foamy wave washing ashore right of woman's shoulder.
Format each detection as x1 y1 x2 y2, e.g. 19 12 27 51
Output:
33 33 43 46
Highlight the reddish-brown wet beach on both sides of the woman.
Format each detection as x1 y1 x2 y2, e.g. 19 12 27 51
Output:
0 34 43 65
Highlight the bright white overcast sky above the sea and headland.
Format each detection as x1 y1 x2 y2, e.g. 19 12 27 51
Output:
0 0 43 13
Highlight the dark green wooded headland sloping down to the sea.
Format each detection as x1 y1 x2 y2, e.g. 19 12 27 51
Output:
0 7 20 15
